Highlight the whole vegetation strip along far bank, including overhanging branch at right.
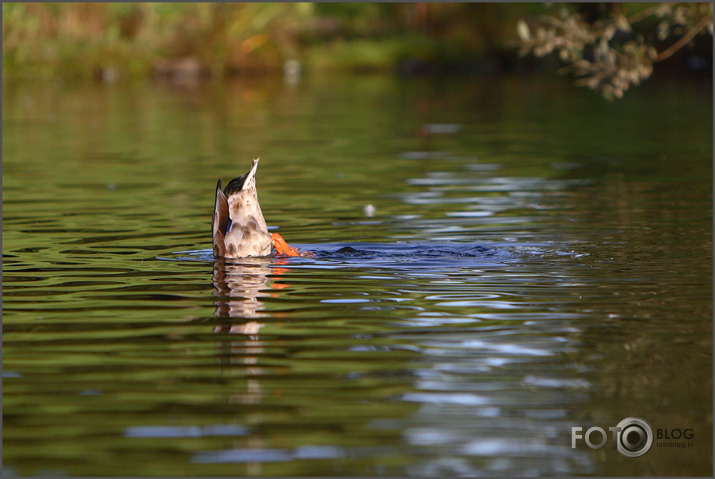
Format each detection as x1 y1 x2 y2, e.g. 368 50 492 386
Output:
2 2 713 97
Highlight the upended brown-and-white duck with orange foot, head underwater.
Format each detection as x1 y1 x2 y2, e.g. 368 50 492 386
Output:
211 158 304 258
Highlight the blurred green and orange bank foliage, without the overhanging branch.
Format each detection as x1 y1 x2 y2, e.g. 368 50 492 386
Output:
2 2 712 94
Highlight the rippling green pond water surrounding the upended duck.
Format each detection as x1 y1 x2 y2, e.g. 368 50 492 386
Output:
2 71 713 476
